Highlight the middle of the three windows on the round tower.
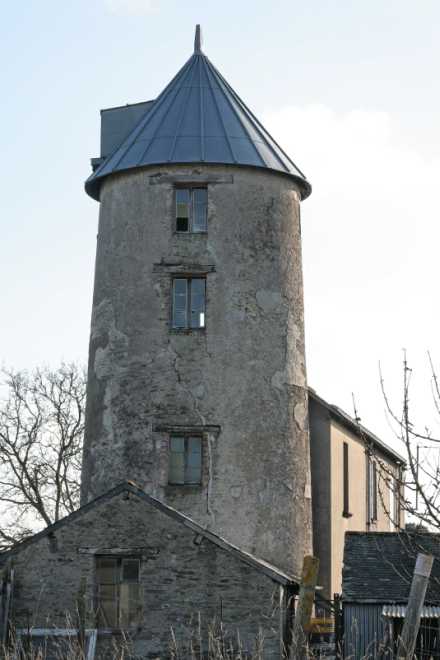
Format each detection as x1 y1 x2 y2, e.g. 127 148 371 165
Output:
172 277 206 328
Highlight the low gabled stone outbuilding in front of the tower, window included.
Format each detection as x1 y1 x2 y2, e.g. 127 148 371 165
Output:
2 482 297 658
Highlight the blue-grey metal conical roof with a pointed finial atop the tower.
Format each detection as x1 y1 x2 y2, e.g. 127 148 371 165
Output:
86 26 311 200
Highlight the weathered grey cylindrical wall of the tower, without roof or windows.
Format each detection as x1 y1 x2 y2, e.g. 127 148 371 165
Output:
82 165 312 574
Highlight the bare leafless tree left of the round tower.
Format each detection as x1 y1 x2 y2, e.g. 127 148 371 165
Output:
0 363 86 550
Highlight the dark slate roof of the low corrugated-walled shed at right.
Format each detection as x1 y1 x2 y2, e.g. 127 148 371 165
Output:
342 531 440 604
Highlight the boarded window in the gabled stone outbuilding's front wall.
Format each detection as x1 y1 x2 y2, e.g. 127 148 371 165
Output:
96 557 141 628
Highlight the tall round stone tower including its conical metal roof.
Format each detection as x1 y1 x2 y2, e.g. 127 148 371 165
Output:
82 28 311 573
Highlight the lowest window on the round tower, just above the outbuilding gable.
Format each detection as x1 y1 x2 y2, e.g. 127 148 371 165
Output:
168 435 202 485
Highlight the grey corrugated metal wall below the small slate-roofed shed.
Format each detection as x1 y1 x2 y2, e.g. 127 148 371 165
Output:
343 604 387 660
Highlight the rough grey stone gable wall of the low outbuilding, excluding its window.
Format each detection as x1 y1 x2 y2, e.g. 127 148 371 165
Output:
3 484 292 658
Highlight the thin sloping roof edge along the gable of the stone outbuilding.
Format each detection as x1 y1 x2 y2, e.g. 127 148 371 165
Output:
0 481 299 587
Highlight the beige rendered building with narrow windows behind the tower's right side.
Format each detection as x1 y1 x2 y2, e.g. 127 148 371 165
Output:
309 389 405 598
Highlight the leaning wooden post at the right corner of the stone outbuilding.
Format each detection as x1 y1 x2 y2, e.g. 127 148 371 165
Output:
290 555 319 660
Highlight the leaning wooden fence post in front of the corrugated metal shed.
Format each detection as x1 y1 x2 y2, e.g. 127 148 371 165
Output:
397 554 434 660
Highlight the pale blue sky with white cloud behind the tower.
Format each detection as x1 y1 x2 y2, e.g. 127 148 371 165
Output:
0 0 440 449
